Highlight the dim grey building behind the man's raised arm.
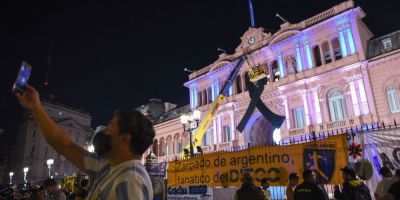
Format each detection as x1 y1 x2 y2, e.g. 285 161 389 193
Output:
9 99 93 183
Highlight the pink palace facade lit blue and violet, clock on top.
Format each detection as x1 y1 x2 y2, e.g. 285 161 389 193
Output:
153 1 400 161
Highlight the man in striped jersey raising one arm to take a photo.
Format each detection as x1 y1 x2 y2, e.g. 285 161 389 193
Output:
15 85 155 199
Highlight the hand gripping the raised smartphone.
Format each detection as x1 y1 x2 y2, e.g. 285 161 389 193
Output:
15 85 40 111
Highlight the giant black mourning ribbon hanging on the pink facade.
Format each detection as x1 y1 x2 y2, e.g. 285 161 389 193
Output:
236 76 285 132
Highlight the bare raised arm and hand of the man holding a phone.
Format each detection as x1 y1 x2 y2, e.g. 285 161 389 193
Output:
16 85 85 170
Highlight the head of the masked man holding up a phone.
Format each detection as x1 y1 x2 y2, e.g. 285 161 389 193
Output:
93 110 155 158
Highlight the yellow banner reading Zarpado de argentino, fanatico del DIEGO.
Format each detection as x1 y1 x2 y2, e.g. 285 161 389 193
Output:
167 134 348 187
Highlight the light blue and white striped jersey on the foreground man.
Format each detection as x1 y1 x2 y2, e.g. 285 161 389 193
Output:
84 152 153 200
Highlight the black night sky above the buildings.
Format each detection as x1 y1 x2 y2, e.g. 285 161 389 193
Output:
0 0 400 152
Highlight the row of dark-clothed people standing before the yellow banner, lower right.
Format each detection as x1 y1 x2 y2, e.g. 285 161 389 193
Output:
234 166 400 200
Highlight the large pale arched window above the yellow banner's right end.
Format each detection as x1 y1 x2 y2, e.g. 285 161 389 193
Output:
328 89 347 121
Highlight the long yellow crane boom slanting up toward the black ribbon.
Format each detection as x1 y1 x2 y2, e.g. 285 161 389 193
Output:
186 56 245 156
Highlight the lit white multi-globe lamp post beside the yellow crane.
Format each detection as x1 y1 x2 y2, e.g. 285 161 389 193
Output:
181 110 201 158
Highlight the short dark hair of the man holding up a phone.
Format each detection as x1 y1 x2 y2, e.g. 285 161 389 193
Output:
114 110 156 155
